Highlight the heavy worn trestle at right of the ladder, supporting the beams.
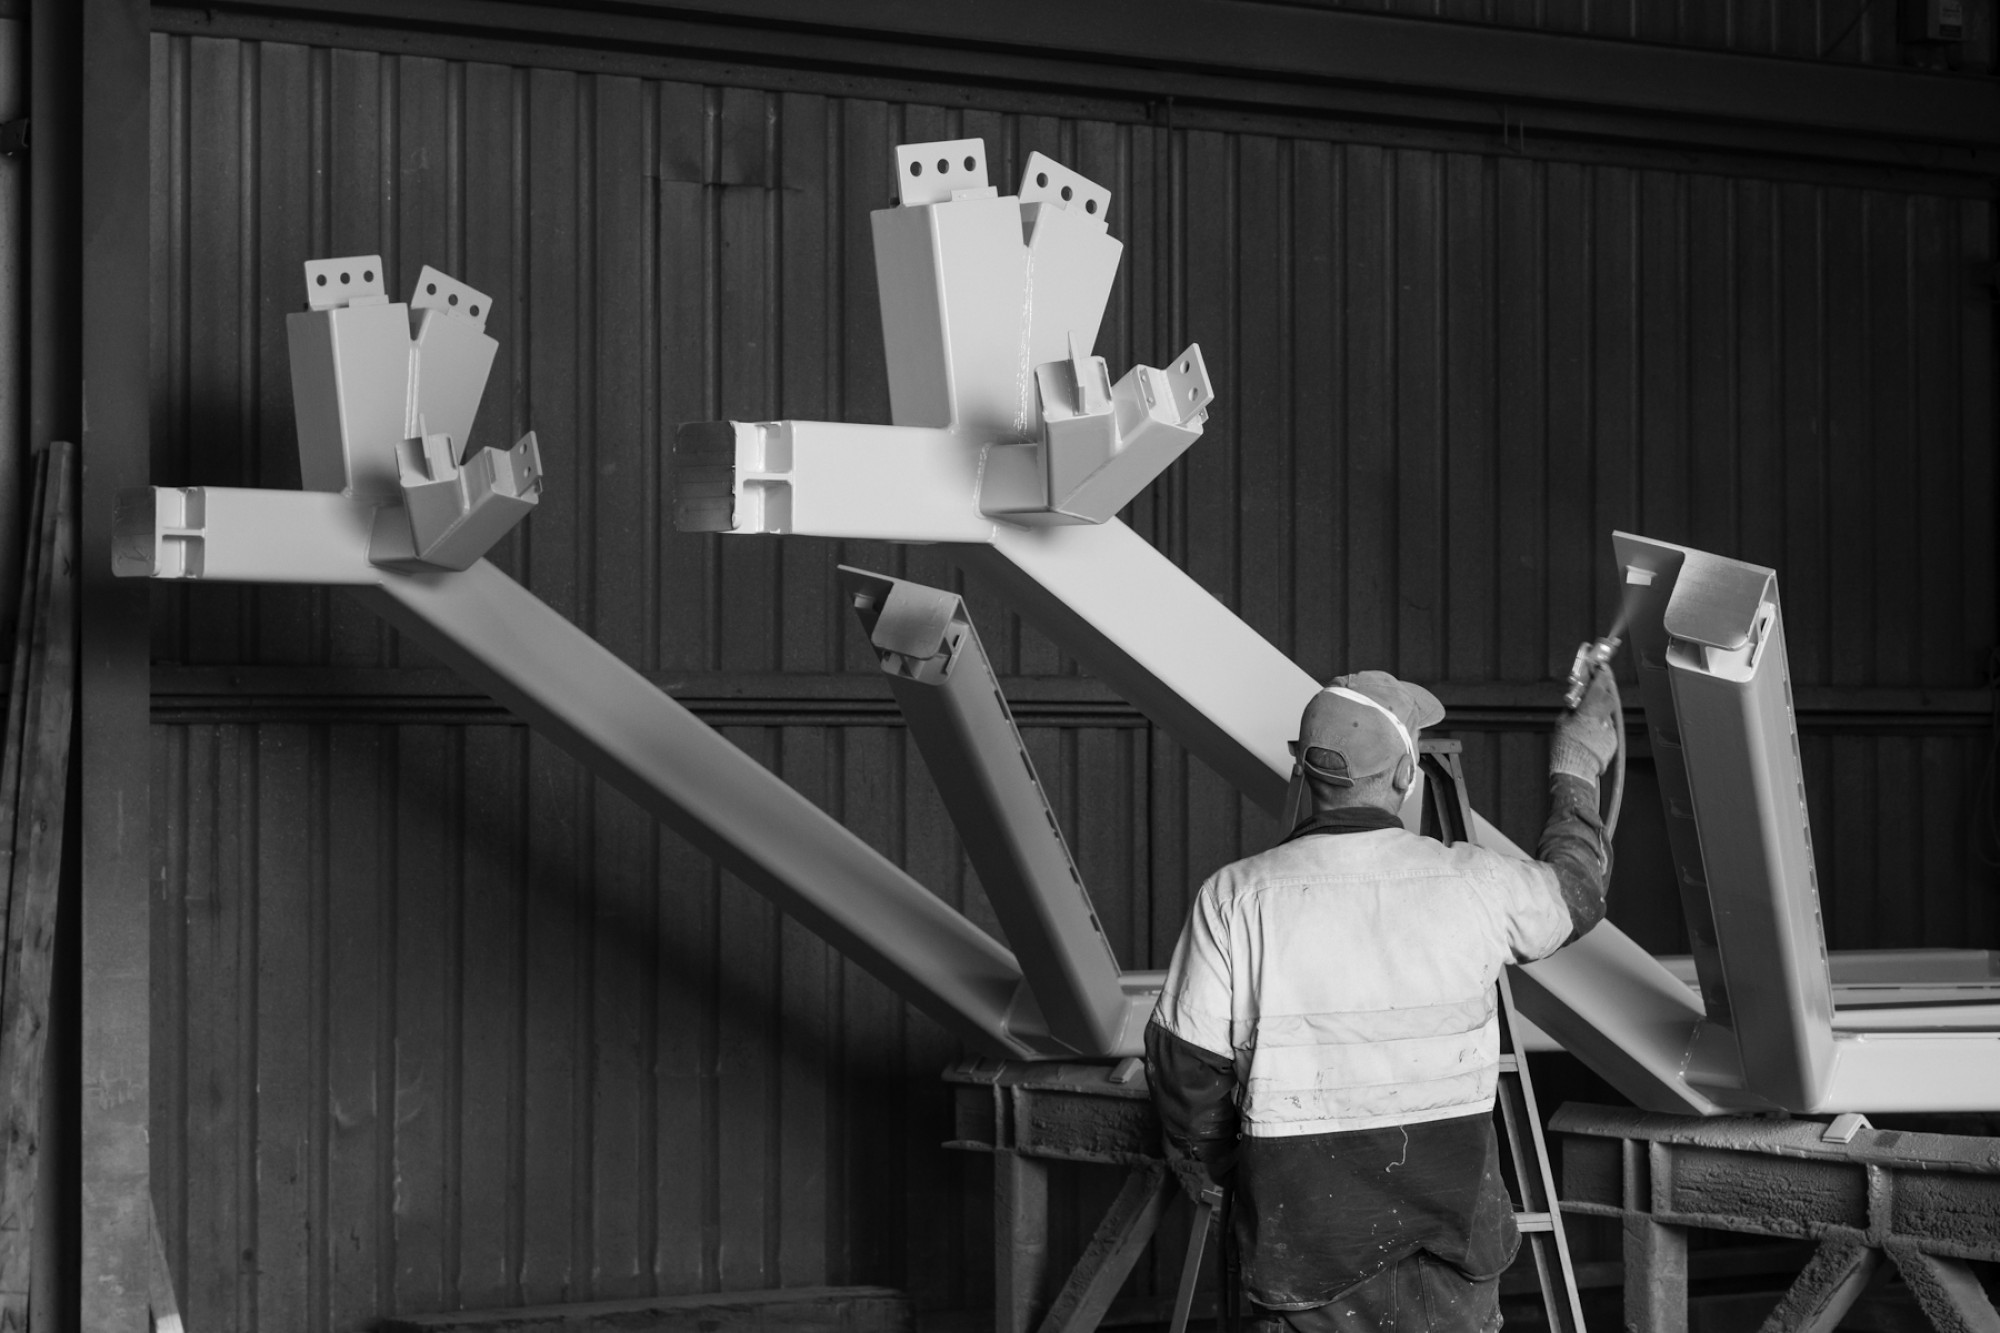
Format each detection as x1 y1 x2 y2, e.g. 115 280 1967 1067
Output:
1550 1103 2000 1333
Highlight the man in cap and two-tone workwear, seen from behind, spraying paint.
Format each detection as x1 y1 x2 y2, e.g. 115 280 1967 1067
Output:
1146 671 1618 1333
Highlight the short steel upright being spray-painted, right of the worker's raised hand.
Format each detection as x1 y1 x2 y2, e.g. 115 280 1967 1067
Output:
1612 532 1834 1111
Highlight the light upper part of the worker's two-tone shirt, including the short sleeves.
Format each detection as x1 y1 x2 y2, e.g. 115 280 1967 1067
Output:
1154 829 1572 1137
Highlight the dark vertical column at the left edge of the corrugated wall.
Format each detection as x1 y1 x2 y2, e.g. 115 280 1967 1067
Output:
78 0 152 1329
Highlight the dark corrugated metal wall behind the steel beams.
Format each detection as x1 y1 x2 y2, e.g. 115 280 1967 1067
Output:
152 23 2000 1329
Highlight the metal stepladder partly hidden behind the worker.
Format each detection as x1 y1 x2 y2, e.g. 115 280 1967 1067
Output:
1422 741 1584 1333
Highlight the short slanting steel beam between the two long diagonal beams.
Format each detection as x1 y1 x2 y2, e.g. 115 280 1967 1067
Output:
840 564 1152 1055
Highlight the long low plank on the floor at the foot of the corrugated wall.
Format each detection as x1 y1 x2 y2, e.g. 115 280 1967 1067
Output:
380 1287 916 1333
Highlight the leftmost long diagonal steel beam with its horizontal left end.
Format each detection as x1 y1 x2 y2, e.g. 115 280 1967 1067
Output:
114 486 1068 1059
